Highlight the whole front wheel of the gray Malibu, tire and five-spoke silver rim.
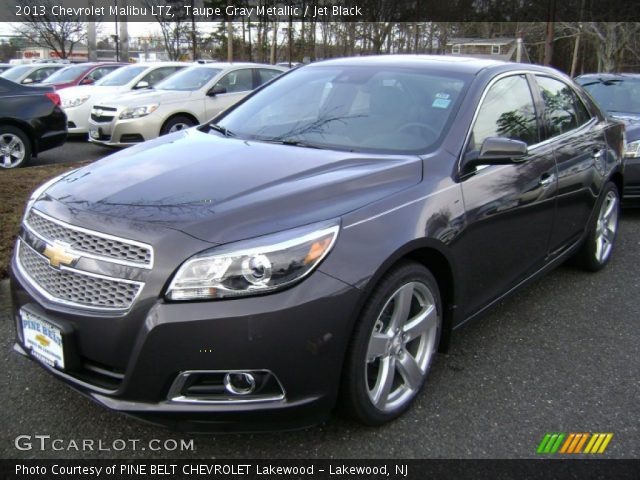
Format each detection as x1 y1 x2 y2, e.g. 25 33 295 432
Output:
341 262 442 425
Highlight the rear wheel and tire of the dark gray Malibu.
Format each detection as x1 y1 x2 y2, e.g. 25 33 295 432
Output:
573 182 620 272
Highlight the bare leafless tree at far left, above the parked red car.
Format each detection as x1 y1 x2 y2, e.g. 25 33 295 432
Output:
14 0 87 59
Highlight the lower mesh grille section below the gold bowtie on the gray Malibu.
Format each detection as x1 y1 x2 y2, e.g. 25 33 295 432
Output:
17 240 142 310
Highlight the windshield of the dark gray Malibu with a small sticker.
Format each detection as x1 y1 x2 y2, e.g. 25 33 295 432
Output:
219 66 467 153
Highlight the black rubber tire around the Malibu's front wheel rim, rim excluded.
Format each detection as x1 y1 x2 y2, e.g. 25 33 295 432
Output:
342 262 442 425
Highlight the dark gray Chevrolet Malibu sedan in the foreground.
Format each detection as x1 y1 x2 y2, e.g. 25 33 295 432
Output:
12 56 623 431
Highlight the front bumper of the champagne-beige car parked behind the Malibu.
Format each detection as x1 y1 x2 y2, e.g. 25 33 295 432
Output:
89 114 162 147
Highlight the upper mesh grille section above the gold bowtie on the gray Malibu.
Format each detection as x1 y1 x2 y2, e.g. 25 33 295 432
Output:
27 210 152 267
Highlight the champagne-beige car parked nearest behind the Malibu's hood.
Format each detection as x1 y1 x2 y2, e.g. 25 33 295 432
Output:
89 62 286 147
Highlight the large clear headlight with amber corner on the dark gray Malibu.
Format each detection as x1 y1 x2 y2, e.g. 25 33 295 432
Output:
166 222 340 300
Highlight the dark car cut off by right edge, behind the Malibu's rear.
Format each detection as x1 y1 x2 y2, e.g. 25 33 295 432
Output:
576 73 640 205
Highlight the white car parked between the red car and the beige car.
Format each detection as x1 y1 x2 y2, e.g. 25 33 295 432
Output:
60 62 189 136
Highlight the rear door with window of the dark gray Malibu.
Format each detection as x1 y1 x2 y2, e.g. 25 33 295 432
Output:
535 74 607 254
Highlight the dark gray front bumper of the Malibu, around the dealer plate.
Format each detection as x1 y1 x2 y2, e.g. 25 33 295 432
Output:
11 258 360 431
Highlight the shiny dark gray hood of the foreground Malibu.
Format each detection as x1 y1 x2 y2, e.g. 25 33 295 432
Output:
46 129 422 243
